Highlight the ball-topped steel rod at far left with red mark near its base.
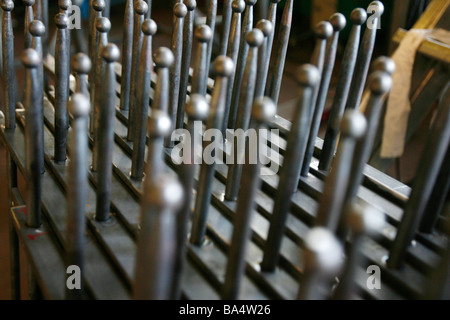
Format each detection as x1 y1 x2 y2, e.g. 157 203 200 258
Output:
21 47 44 228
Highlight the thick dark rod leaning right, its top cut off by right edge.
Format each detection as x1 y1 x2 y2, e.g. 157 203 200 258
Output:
387 86 450 269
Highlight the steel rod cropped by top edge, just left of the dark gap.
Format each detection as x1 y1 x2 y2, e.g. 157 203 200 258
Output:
266 0 294 105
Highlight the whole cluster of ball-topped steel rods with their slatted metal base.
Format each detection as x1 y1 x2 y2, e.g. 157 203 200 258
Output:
1 0 450 299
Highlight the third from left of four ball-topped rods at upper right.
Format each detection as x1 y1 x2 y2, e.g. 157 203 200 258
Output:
319 8 367 171
